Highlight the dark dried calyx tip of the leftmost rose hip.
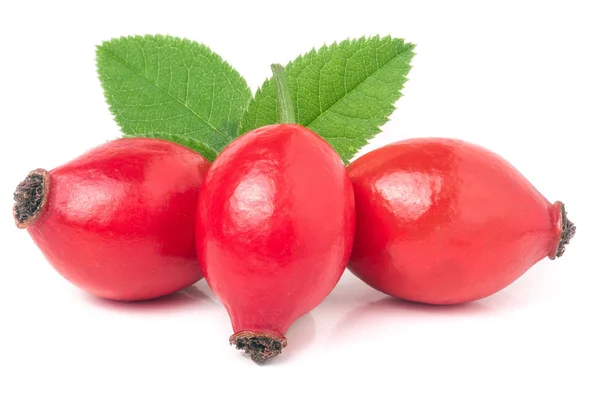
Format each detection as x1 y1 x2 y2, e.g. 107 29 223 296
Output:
13 169 49 229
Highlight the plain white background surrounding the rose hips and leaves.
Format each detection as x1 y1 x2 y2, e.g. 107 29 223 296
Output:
0 0 600 400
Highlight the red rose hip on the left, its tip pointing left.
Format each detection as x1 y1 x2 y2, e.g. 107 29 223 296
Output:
14 138 210 300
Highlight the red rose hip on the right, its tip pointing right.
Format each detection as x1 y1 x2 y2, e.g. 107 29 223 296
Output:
348 138 575 304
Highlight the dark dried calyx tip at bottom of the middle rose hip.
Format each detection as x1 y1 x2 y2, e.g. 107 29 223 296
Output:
229 331 287 364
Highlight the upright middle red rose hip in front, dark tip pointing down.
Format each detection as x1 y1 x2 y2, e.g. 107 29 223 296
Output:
197 124 355 363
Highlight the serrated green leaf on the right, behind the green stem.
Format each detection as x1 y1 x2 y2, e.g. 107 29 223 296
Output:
240 36 415 163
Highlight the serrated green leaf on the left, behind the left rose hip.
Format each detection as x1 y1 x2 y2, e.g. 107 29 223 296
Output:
96 35 252 160
